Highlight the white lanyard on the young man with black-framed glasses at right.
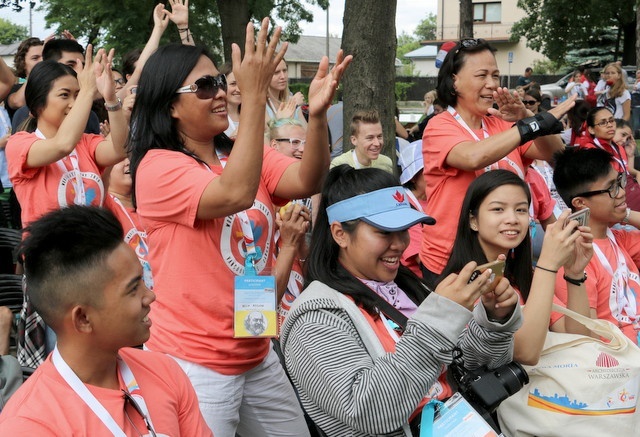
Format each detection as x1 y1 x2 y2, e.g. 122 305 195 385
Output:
593 229 640 324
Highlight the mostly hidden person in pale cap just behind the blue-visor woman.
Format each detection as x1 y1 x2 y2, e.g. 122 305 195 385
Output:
398 140 427 277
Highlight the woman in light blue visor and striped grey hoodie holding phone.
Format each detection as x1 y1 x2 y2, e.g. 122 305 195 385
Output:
280 165 521 436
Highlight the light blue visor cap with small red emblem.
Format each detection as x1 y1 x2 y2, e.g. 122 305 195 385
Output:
327 187 436 232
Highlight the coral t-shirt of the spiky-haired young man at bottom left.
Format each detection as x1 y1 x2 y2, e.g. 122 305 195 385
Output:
0 348 213 437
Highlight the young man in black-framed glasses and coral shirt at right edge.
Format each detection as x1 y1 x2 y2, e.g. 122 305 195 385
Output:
553 148 640 342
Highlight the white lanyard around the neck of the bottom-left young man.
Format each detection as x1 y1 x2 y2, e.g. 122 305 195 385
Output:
51 346 153 437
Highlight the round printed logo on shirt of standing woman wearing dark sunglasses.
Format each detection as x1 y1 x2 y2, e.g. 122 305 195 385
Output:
220 199 273 276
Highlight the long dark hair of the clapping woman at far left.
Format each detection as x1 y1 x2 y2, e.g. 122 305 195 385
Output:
19 61 77 132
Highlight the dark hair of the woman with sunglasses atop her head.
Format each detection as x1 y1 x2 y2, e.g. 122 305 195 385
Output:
436 38 496 107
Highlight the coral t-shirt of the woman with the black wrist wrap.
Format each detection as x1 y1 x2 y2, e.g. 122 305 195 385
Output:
420 111 532 274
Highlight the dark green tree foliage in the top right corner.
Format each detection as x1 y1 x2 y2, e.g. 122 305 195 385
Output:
512 0 636 63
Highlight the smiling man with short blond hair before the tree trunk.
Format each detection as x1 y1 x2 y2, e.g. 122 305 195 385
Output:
331 111 393 174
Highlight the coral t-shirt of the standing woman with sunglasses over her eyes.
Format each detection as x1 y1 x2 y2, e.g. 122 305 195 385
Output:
135 147 297 375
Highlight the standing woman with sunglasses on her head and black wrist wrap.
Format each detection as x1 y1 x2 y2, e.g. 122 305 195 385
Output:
420 35 574 286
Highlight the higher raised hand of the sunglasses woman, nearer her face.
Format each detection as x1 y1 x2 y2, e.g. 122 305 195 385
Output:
231 18 288 104
